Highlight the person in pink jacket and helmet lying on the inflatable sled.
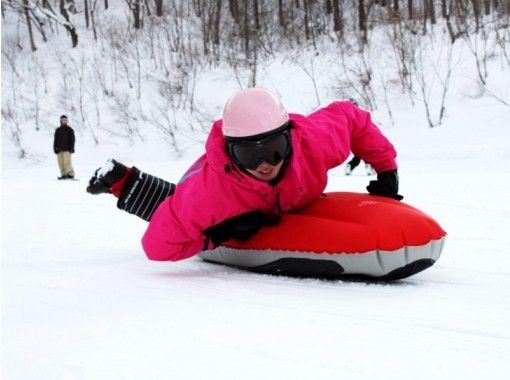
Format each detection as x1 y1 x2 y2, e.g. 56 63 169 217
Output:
87 88 402 261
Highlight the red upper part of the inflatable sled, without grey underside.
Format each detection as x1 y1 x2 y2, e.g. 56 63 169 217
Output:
224 192 446 254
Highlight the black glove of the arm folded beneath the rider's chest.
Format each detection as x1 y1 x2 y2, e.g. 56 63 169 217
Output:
204 210 279 246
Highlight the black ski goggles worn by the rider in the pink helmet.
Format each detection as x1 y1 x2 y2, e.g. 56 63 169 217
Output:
227 124 291 170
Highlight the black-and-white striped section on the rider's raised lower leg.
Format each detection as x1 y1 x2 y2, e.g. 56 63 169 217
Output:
117 167 175 221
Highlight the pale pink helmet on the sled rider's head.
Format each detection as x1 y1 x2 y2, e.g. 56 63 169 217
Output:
222 87 289 137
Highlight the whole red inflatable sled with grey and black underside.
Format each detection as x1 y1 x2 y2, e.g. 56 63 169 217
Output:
200 193 446 281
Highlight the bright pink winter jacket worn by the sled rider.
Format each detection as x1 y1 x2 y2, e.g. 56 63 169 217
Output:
142 102 397 261
